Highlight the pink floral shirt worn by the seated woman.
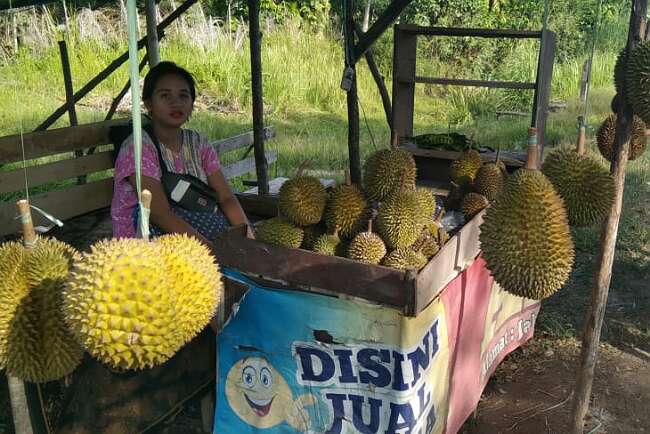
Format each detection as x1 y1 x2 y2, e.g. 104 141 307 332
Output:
111 130 220 238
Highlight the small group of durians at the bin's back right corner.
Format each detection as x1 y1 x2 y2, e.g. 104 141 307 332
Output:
445 149 508 221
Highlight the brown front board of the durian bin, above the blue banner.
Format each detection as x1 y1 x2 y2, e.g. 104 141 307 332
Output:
213 226 413 310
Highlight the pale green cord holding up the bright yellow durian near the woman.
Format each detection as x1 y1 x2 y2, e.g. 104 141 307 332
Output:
126 0 149 239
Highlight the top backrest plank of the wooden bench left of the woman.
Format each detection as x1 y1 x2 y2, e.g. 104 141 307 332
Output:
0 119 128 164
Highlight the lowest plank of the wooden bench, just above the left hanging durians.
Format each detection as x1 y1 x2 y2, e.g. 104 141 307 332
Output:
0 178 113 236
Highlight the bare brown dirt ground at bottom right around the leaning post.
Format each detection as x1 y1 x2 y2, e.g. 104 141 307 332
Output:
461 337 650 434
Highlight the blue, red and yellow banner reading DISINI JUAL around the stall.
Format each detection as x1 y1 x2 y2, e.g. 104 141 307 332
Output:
214 257 539 434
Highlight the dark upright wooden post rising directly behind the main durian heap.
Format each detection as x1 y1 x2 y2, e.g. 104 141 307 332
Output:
344 0 361 185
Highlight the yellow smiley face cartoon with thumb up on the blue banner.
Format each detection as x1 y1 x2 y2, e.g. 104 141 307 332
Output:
226 357 316 432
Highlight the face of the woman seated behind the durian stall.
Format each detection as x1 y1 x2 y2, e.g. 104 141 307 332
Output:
144 74 194 128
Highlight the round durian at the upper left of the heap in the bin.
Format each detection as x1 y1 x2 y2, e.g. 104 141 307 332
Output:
278 175 327 226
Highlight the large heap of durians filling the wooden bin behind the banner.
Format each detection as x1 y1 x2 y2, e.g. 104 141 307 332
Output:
256 148 449 270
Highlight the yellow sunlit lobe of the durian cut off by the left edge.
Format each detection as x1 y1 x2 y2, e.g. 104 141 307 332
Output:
0 241 29 370
